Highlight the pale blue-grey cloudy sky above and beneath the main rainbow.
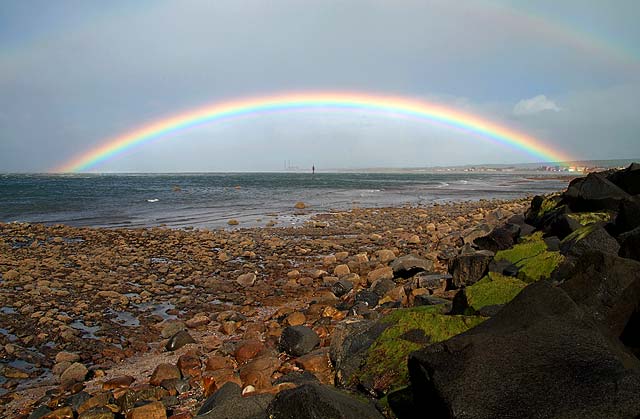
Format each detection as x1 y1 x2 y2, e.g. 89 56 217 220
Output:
0 0 640 172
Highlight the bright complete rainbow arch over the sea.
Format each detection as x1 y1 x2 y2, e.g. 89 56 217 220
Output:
54 92 572 172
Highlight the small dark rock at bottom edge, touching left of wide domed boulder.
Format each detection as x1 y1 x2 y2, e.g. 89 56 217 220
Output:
194 382 273 419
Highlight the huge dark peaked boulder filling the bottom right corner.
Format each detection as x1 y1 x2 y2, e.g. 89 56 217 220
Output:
409 281 640 419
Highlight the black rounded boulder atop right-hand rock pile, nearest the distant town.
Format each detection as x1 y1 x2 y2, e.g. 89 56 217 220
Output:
564 173 631 212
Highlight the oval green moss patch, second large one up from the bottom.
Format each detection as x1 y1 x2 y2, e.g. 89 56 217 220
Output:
465 272 527 311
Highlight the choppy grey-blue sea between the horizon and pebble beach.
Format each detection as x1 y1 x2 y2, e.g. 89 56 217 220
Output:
0 173 569 229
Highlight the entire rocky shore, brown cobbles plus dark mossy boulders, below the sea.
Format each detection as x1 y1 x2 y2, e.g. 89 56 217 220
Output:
0 165 640 419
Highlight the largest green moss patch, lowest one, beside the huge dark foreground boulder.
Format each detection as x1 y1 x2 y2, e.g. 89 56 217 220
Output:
356 306 485 392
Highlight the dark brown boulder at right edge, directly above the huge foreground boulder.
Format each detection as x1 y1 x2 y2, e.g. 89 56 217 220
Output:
560 251 640 337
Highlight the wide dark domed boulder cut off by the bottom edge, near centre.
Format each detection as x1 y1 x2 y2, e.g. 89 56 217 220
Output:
267 383 383 419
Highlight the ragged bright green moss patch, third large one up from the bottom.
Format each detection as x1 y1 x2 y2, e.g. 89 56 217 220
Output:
495 232 564 283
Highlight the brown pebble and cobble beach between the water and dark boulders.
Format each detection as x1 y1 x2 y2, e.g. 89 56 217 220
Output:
0 198 529 415
